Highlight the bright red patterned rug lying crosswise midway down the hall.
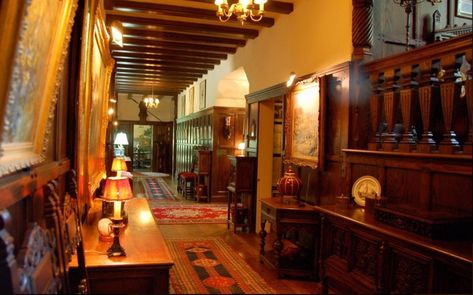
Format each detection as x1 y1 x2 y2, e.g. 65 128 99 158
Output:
151 203 228 224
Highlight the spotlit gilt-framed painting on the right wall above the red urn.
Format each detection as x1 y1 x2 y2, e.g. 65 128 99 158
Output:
284 76 325 169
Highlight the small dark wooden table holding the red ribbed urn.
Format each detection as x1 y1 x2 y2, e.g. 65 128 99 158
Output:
260 197 320 279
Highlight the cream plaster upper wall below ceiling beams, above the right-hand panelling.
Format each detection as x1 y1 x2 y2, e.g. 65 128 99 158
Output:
178 0 352 118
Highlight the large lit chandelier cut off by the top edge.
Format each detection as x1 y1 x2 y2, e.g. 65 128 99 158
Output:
215 0 268 25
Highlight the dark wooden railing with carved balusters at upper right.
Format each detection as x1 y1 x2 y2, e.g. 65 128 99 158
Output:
364 34 473 154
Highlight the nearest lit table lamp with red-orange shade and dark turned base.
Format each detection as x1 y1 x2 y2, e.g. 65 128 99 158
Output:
102 177 134 257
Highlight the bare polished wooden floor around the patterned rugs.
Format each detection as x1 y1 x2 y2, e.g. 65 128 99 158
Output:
134 178 321 294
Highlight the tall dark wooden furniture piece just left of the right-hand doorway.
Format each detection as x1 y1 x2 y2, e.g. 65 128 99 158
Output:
227 156 256 232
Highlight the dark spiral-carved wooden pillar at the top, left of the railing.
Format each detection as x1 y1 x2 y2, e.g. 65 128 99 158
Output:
352 0 373 60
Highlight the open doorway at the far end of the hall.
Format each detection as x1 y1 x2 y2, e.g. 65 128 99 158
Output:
133 124 153 171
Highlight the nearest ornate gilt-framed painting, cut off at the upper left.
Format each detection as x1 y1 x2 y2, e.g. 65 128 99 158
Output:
0 0 77 177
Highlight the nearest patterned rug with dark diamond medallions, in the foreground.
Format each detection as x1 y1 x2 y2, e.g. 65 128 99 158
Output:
166 238 275 294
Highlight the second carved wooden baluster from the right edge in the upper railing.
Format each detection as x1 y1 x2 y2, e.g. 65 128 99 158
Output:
439 56 460 154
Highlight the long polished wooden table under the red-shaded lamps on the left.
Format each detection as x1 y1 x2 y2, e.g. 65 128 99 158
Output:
70 198 174 294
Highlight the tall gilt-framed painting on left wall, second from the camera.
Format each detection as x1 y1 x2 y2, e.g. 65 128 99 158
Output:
76 0 114 205
